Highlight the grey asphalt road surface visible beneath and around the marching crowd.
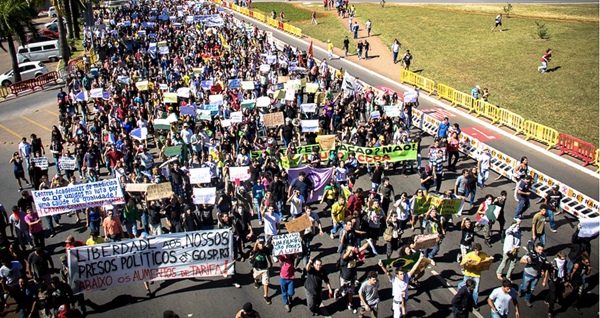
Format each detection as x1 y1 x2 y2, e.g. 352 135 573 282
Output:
0 8 599 317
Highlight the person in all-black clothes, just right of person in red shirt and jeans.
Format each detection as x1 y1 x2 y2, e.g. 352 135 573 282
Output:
304 259 333 316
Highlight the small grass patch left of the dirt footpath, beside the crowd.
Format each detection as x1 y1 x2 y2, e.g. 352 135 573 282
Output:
252 2 356 53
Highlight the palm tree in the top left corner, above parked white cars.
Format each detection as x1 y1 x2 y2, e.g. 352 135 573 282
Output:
0 0 37 82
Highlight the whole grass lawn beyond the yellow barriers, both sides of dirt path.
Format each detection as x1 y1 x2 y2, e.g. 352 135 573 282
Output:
253 3 599 145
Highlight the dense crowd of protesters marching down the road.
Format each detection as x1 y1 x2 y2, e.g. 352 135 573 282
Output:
0 0 591 317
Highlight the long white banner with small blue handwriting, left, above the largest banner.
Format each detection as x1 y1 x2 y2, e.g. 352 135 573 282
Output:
31 179 125 216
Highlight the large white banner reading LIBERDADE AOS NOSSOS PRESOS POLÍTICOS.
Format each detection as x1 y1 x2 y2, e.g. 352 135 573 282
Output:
67 229 233 294
